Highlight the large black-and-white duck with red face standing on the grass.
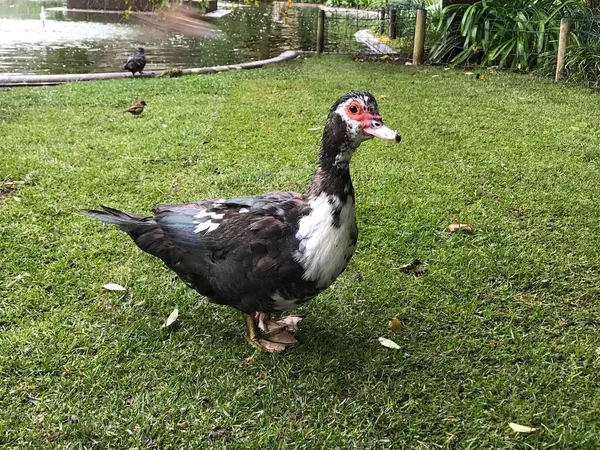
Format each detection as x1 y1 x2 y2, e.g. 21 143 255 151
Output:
83 91 400 351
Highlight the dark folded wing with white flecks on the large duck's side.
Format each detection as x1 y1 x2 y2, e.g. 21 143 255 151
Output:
154 192 314 311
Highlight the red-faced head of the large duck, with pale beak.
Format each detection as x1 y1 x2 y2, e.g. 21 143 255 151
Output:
327 91 401 147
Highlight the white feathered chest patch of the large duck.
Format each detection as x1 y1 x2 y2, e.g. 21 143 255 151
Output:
296 194 358 289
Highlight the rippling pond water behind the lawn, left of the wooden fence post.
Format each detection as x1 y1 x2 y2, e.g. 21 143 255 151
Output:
0 0 317 74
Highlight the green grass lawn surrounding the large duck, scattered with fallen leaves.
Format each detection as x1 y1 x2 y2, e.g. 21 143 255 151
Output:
0 58 600 449
